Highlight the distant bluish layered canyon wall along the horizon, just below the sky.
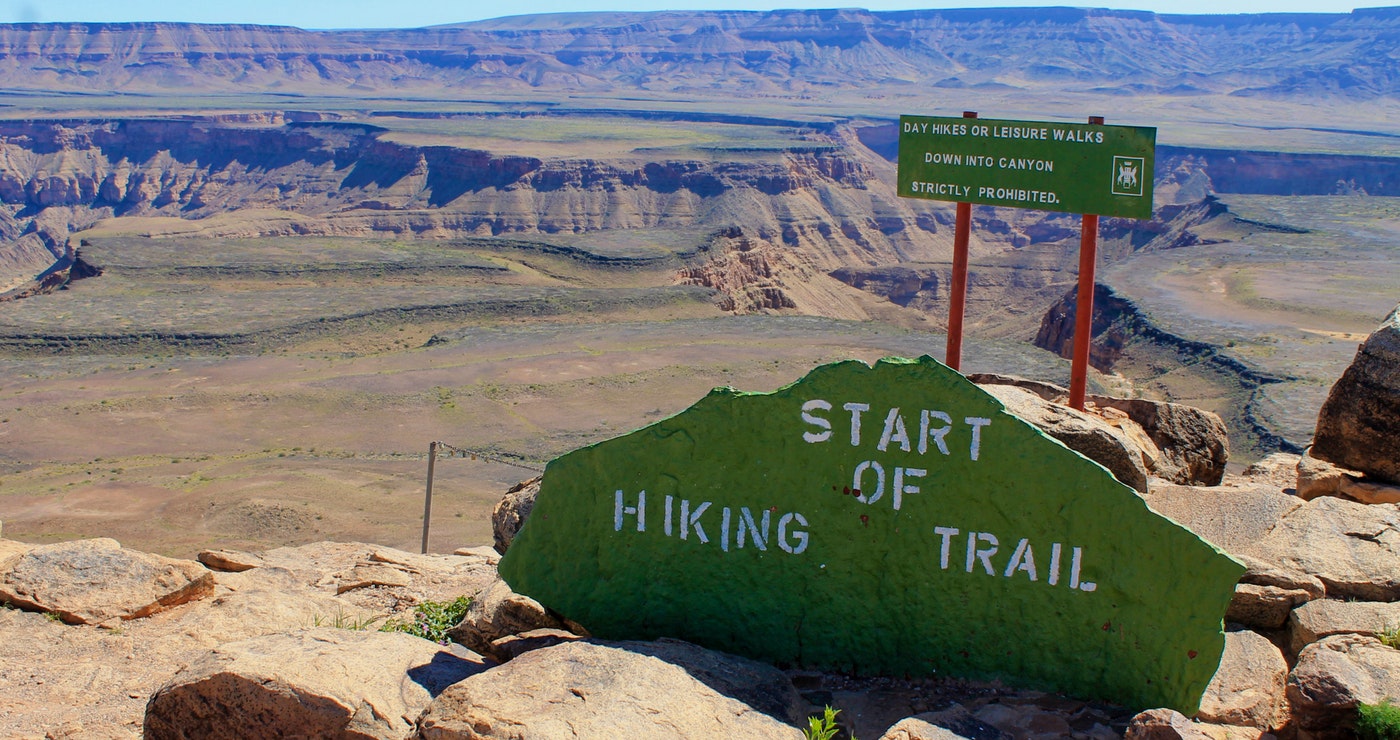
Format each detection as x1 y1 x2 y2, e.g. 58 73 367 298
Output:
0 8 1400 99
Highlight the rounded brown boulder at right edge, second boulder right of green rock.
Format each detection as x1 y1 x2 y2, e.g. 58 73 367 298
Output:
1288 635 1400 740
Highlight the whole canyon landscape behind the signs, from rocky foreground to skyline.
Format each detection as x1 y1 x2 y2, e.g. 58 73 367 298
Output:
0 8 1400 553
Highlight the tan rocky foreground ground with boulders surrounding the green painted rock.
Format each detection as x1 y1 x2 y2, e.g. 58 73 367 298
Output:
0 311 1400 740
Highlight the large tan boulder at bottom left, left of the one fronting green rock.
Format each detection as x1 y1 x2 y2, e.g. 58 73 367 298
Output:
143 628 486 740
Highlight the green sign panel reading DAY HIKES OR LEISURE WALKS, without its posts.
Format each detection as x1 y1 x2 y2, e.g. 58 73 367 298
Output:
899 116 1156 218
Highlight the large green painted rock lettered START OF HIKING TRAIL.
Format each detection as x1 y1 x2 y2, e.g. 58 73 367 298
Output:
500 357 1243 713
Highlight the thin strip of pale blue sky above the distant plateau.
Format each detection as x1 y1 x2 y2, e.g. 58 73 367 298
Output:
8 0 1400 28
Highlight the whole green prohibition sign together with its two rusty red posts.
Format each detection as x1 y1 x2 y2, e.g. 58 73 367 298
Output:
899 111 1156 410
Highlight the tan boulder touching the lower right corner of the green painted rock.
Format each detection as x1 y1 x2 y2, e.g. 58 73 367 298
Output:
1196 629 1288 730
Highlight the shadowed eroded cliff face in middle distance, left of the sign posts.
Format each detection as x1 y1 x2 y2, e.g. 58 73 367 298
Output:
0 115 949 318
